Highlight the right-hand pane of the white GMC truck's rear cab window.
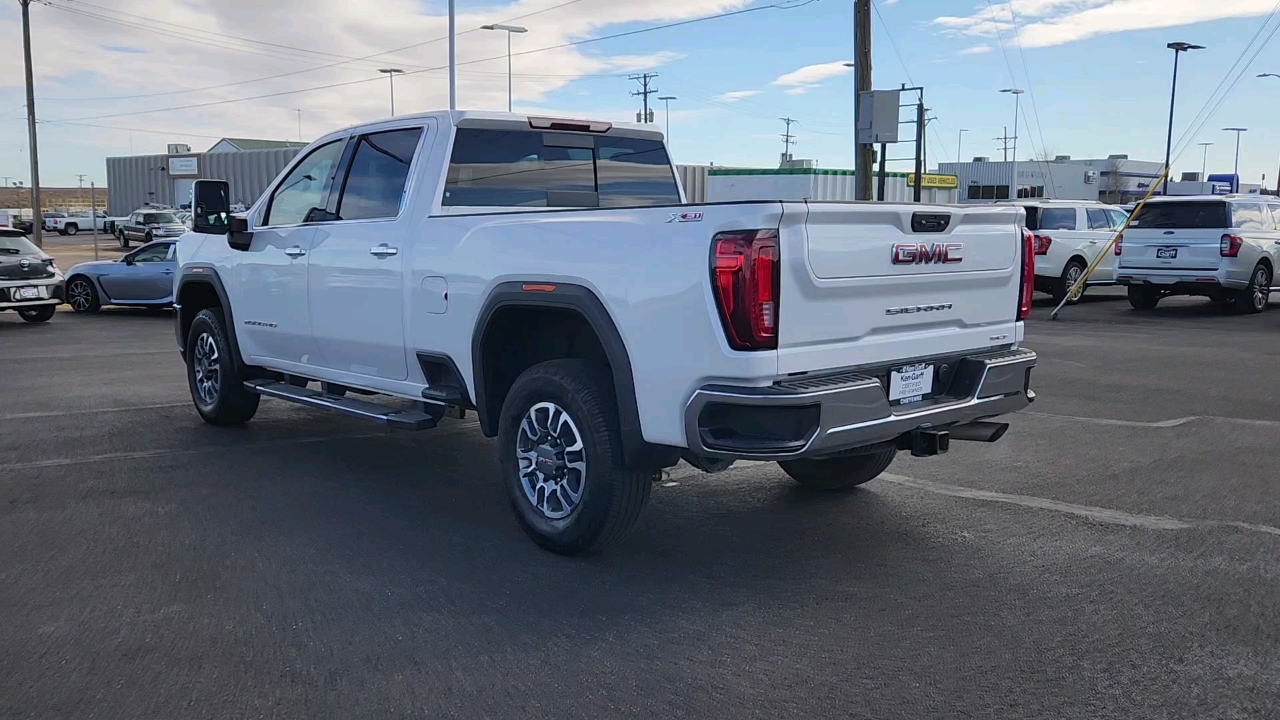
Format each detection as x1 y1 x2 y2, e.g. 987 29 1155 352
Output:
595 137 680 208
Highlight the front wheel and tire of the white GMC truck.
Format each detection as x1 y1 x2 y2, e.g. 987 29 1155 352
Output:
187 307 261 425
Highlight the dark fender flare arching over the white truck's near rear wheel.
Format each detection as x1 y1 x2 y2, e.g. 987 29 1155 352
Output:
471 281 680 468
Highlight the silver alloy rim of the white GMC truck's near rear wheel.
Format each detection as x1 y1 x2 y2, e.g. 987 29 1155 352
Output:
516 402 586 520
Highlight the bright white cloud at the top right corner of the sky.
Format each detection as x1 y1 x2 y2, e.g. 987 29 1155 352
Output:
933 0 1275 47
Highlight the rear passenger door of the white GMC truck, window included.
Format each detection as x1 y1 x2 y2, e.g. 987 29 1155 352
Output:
307 123 434 380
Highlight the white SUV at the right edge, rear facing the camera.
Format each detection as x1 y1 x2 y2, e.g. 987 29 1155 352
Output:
1116 195 1280 313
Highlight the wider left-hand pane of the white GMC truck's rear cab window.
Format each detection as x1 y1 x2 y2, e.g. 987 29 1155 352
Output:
440 128 595 208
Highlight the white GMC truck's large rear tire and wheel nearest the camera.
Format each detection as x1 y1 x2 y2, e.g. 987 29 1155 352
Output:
498 360 653 555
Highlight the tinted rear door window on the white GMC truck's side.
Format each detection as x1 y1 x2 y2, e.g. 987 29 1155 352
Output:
338 128 422 220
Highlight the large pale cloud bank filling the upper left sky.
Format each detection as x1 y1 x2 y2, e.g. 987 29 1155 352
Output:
0 0 751 151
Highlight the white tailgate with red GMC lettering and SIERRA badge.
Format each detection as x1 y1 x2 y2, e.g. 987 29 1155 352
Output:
778 202 1023 374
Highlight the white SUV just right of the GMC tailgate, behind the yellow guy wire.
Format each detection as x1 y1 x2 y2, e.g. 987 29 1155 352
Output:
1018 200 1129 302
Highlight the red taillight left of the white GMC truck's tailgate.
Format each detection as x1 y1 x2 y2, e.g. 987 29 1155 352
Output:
712 231 781 350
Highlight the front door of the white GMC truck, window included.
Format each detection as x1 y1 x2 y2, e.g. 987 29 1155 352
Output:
228 138 347 365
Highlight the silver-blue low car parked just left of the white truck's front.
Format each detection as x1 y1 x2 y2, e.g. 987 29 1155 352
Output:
67 240 178 313
